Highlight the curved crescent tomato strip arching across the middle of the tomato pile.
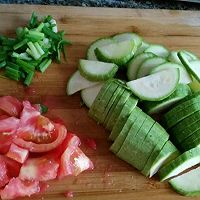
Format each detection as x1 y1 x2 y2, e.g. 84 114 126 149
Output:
13 124 67 153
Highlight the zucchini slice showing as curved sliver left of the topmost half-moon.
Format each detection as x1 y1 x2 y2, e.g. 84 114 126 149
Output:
86 38 114 60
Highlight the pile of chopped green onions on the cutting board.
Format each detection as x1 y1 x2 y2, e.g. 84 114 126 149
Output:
0 12 71 86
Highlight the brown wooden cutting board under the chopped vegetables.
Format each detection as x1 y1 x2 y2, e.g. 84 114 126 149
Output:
0 5 200 200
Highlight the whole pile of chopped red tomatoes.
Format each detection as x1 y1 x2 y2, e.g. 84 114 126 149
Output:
0 96 93 200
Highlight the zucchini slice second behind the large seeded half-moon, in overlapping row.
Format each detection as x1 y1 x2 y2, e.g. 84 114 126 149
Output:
137 57 167 79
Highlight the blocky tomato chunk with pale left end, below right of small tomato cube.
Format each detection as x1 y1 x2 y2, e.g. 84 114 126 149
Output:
19 157 59 181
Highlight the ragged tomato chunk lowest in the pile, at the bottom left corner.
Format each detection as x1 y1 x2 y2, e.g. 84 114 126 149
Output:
0 178 40 200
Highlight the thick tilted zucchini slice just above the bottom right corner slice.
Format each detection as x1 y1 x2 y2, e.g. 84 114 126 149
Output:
159 147 200 181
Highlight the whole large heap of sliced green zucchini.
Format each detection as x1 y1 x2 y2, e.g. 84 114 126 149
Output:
67 33 200 196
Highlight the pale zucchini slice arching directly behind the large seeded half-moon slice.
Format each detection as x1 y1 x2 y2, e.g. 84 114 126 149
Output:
150 62 192 84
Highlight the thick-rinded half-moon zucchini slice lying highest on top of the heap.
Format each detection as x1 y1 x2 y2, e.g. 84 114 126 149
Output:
95 40 137 66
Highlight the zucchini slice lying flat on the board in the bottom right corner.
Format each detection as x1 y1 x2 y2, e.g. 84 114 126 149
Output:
169 167 200 197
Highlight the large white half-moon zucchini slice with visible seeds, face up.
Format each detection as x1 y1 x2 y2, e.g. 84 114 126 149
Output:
127 68 180 101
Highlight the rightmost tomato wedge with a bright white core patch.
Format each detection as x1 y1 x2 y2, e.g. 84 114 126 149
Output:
58 146 94 178
